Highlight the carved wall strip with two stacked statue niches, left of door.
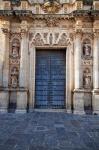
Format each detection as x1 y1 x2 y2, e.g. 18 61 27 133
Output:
9 37 20 88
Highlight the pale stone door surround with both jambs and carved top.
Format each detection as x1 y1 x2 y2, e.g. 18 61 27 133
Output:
29 32 73 112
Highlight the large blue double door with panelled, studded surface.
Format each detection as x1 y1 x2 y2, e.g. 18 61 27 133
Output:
35 50 66 108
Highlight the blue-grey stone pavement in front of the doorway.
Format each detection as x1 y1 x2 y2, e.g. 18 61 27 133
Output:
0 112 99 150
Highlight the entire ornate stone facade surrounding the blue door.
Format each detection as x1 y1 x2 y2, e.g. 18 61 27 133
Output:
0 0 99 114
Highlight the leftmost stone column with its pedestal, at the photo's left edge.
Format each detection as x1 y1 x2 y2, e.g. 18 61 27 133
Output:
0 21 10 112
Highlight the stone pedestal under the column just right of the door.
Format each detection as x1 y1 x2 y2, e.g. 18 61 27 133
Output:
73 89 85 114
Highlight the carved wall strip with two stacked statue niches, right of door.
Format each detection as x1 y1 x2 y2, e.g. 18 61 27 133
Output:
82 38 93 89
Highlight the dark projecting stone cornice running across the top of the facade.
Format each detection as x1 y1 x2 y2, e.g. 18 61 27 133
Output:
0 10 99 19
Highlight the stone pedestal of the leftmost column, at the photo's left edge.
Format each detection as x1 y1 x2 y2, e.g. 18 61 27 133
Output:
0 91 9 112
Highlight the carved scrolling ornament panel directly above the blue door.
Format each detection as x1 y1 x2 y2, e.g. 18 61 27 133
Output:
30 32 71 47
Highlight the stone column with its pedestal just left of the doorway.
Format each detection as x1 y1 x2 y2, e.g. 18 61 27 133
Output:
16 26 29 112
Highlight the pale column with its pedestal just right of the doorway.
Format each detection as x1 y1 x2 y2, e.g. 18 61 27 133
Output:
73 33 84 114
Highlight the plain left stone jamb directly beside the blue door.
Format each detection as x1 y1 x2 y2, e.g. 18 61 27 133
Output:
29 45 36 111
